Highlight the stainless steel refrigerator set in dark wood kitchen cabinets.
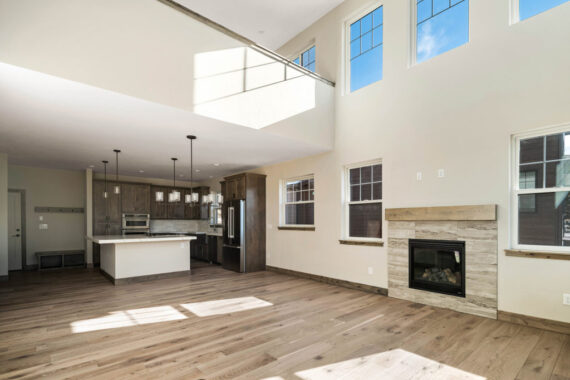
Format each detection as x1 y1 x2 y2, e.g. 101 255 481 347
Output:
223 200 247 273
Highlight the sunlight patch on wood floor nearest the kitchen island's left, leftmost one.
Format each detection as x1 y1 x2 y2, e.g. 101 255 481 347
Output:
71 306 188 333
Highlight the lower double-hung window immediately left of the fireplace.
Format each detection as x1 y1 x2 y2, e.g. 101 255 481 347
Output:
345 162 382 240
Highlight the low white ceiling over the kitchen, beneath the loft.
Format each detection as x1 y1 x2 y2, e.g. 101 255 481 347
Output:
0 63 323 181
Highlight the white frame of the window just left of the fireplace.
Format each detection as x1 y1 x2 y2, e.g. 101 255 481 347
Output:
341 159 385 243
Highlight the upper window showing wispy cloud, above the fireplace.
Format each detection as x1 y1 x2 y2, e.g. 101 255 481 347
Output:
413 0 469 63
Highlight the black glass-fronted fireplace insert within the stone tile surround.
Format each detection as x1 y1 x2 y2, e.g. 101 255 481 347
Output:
408 239 465 297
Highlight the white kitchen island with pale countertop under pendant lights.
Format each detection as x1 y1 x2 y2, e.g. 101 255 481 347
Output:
88 235 196 285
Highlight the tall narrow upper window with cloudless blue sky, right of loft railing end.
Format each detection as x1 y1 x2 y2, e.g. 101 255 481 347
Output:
348 6 384 91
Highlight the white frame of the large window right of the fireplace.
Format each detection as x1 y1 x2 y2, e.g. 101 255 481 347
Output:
510 124 570 254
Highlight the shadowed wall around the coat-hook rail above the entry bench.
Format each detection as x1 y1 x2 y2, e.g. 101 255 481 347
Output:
8 165 86 265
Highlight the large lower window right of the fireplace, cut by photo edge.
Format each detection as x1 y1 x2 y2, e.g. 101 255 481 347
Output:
513 127 570 249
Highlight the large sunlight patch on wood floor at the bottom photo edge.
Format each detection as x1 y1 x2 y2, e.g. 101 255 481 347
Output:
295 349 485 380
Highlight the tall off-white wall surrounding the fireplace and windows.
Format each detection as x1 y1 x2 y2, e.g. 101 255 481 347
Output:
258 0 570 322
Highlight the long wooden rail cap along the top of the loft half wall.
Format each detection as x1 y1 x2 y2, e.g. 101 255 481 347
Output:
156 0 335 87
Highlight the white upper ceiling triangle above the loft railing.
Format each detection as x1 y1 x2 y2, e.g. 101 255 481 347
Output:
176 0 344 50
